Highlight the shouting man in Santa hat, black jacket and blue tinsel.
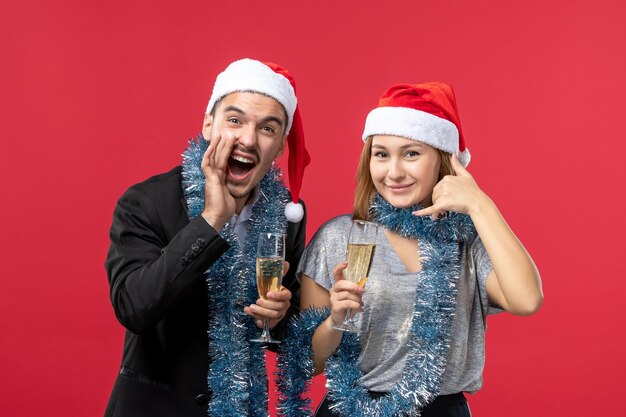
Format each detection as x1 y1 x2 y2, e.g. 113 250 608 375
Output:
105 59 309 417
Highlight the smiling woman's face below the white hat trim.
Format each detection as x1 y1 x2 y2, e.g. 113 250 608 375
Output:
370 135 441 208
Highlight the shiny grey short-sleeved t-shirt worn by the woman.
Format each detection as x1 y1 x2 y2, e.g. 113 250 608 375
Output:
297 215 499 395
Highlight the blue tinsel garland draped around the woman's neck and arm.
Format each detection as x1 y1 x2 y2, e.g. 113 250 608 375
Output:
278 195 476 417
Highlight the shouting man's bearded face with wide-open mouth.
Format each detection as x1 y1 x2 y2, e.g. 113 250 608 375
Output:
202 92 287 206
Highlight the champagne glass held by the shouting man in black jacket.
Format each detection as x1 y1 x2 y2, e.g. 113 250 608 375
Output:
251 233 285 343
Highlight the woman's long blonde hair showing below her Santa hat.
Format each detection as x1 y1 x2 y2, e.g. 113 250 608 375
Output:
353 136 454 220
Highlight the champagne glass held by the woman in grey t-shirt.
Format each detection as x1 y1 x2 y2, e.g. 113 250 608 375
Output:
333 220 378 333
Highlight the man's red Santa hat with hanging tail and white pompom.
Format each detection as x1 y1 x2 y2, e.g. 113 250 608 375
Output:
206 58 311 222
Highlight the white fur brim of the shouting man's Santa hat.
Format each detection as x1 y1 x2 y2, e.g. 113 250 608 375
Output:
206 58 298 134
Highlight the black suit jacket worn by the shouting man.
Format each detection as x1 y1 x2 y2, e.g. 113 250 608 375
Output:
105 167 306 417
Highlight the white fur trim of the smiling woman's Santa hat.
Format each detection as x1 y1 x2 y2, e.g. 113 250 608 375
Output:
363 107 470 166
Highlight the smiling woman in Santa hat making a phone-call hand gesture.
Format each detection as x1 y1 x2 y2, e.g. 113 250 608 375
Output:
279 83 543 417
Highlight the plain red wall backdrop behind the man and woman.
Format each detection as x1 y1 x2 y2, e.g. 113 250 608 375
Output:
0 0 626 417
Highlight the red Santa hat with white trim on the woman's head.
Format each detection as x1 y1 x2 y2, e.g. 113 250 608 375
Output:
363 81 471 166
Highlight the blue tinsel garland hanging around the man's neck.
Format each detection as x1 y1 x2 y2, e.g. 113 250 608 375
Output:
182 136 289 417
